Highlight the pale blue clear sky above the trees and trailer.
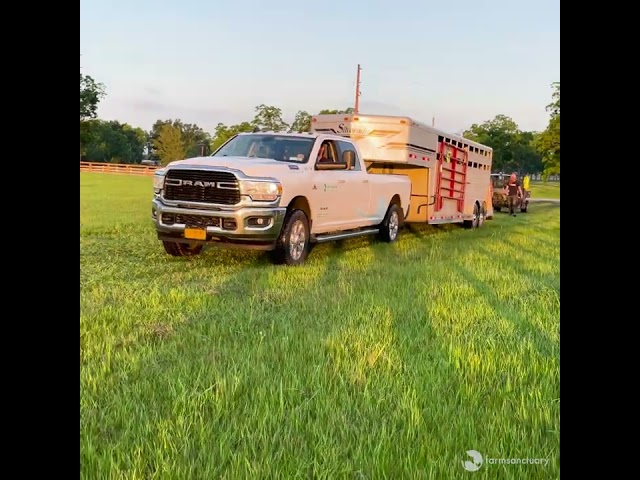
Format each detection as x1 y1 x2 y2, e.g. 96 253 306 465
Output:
80 0 560 133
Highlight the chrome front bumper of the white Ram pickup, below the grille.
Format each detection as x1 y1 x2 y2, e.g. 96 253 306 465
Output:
151 198 287 250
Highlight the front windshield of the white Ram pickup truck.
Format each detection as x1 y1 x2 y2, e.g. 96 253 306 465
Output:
212 135 315 163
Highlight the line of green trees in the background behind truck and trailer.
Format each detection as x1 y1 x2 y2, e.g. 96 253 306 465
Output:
80 74 560 174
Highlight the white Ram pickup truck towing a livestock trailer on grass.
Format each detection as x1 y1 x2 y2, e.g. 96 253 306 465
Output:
151 132 411 265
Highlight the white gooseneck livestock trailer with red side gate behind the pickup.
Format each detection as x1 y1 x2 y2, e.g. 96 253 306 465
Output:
311 114 493 228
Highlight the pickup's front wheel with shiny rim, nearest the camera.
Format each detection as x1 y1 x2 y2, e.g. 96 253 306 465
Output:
270 210 310 265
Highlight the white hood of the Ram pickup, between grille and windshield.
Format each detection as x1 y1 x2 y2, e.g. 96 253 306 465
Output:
167 157 304 178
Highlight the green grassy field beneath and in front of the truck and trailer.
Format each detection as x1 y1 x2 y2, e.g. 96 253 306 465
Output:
80 173 560 479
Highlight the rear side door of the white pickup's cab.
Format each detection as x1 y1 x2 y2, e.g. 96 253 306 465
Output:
337 141 372 228
